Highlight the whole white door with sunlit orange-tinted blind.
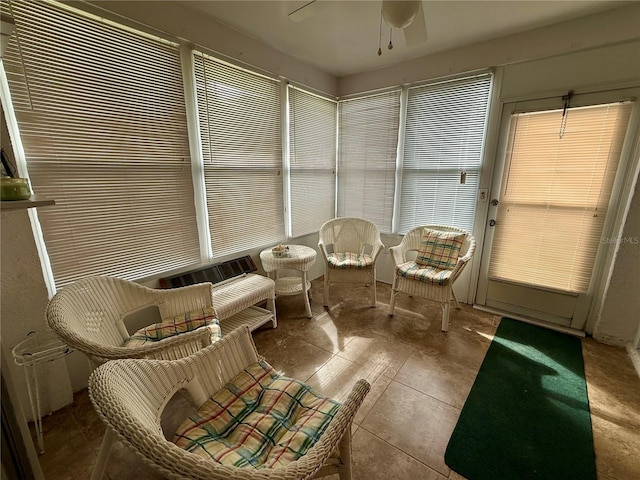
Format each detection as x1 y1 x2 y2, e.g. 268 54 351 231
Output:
476 90 638 329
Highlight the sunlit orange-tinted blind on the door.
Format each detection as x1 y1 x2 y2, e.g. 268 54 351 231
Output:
489 104 631 293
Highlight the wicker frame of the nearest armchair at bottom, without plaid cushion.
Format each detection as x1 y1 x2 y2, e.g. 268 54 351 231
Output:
89 326 370 480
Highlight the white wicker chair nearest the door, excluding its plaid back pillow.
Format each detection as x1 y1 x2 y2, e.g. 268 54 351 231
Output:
389 225 476 332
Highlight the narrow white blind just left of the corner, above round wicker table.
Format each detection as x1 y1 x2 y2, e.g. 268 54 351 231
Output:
288 85 337 237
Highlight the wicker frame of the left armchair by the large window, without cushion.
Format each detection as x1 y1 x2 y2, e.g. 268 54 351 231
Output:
46 276 219 367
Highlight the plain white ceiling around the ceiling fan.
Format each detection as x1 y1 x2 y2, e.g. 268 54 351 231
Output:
181 0 631 77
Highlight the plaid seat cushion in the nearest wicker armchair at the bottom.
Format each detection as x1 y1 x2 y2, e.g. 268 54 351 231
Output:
173 362 340 469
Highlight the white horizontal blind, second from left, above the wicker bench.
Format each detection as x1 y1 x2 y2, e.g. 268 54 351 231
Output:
194 52 284 257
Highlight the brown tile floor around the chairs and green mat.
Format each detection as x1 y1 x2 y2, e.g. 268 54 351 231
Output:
28 280 640 480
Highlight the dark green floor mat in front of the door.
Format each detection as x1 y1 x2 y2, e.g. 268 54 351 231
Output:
445 318 596 480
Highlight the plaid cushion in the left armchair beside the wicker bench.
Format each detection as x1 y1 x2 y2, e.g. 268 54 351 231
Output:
124 307 222 347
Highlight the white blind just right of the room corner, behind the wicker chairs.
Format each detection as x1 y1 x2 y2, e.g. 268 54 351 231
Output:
337 90 400 233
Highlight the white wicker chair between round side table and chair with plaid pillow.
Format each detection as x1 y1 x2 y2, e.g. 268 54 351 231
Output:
318 217 384 307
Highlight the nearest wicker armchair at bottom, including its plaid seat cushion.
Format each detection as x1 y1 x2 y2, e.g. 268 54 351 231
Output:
89 326 370 480
